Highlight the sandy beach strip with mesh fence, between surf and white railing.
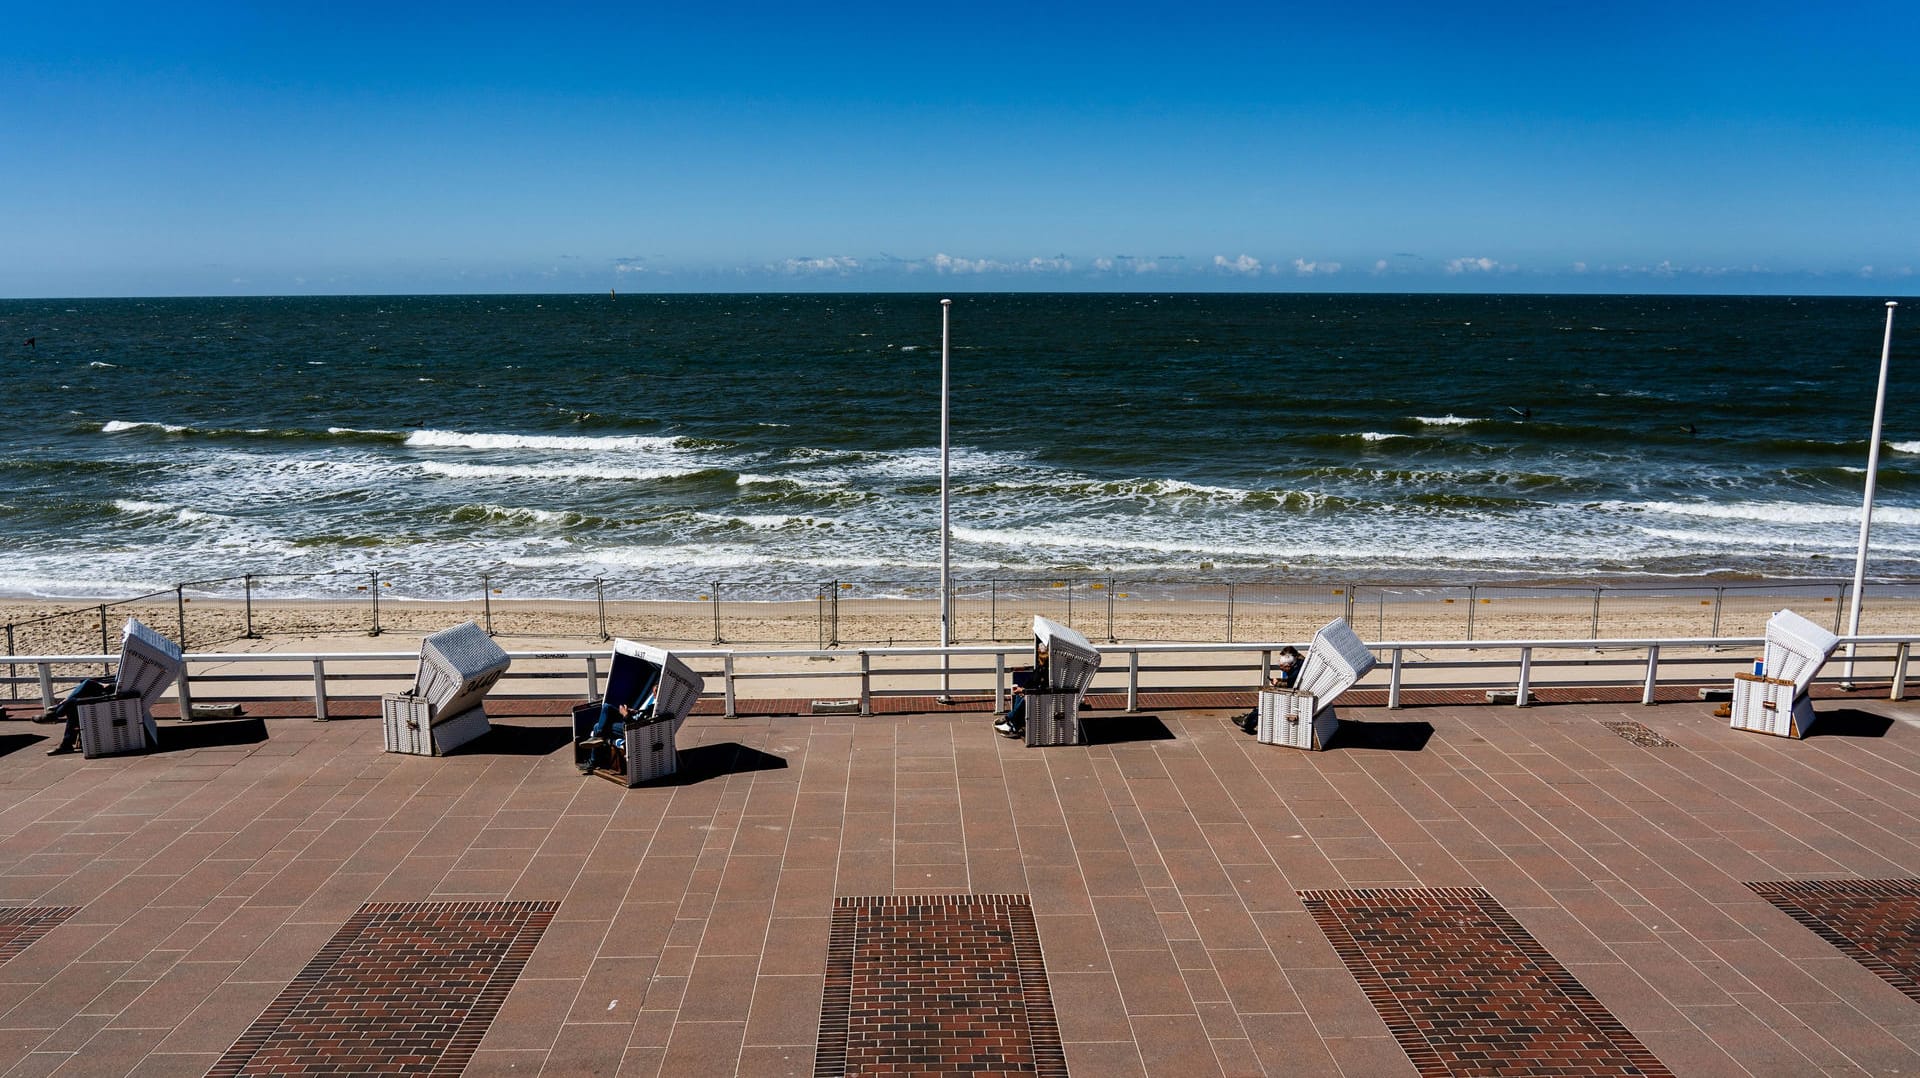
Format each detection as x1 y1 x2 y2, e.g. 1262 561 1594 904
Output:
6 573 1920 684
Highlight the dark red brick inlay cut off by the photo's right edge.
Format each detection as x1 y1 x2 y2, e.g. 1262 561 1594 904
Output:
1747 880 1920 1003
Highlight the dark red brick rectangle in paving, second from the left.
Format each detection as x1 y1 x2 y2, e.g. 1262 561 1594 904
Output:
207 901 559 1078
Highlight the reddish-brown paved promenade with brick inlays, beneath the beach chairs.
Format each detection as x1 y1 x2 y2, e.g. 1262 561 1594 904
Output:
0 692 1920 1078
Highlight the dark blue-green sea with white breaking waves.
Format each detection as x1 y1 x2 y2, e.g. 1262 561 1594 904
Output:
0 294 1920 598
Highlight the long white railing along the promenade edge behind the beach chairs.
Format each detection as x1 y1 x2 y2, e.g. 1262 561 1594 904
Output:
0 634 1920 719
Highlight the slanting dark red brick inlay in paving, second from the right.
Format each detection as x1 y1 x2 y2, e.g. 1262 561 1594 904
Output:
1300 888 1672 1078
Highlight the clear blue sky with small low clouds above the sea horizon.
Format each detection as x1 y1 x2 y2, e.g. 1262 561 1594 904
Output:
0 2 1920 296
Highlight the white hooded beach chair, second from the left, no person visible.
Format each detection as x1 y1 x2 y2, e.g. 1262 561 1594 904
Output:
380 621 513 755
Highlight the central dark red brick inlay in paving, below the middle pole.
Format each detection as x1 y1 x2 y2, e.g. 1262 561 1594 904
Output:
814 895 1068 1078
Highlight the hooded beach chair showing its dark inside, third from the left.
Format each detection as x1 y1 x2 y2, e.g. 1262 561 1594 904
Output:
574 640 707 786
